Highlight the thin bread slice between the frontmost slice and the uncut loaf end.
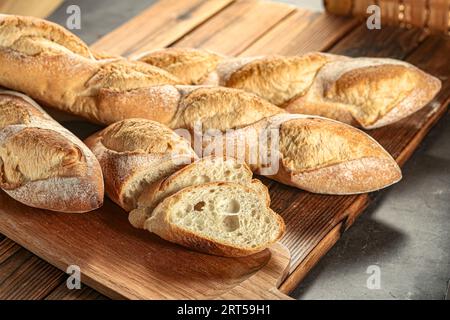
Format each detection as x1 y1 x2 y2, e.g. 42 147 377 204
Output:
128 157 270 228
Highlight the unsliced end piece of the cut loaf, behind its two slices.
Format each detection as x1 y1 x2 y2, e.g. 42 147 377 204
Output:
85 119 197 211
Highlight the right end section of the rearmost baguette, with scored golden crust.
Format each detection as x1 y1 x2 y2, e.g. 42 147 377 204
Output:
287 58 440 128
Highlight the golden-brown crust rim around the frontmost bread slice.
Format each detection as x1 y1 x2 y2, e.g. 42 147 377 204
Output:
145 182 286 257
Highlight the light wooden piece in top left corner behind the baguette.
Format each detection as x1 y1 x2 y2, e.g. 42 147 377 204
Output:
0 0 63 18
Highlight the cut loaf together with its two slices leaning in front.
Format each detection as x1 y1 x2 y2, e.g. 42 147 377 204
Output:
86 119 285 256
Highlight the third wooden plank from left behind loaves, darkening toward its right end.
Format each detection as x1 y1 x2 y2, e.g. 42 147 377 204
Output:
240 9 359 56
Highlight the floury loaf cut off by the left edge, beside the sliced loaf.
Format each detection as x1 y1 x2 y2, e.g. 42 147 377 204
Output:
0 90 104 212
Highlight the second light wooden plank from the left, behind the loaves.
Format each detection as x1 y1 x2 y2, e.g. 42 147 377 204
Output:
174 0 295 55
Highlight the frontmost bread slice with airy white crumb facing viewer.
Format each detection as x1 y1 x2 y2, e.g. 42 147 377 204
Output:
145 182 285 257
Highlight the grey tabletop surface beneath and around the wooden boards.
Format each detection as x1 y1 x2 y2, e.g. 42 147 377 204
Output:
49 0 450 299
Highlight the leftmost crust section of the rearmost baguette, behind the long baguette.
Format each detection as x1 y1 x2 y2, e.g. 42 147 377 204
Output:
132 48 223 84
